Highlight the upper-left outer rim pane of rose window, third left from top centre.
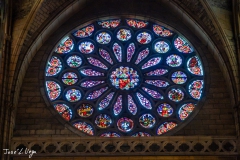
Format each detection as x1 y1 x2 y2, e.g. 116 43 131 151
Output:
55 36 74 54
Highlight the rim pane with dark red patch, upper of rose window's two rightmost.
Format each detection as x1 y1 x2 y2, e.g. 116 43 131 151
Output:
187 56 203 76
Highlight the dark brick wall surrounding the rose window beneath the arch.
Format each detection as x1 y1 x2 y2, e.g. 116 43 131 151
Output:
14 1 235 136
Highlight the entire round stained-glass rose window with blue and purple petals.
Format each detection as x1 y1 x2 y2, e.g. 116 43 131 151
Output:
44 18 205 137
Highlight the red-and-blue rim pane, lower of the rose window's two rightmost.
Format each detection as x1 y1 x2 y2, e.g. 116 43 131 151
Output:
188 80 203 99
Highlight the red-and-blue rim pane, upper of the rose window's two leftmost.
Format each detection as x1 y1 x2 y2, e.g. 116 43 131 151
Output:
46 56 62 76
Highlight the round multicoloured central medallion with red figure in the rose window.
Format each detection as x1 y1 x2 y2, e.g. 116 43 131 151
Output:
110 66 139 90
